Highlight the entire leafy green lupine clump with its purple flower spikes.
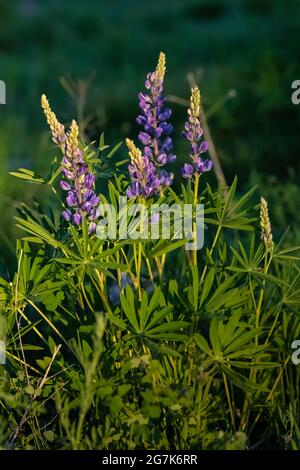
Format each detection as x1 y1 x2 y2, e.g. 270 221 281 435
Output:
0 54 300 450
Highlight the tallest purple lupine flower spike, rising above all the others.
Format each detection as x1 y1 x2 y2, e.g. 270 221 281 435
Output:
137 52 176 187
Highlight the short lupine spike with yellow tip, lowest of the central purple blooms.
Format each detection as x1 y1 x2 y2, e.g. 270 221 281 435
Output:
126 139 160 198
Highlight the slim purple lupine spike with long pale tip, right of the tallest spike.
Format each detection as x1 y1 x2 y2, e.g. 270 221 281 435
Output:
181 87 213 178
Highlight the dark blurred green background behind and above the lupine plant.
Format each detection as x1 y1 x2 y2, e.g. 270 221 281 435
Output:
0 0 300 274
